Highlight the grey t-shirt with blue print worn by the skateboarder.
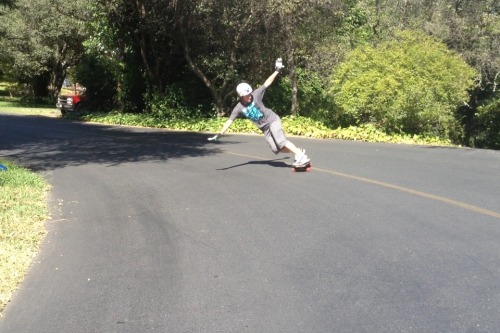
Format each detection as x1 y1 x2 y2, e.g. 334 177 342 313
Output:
229 85 278 131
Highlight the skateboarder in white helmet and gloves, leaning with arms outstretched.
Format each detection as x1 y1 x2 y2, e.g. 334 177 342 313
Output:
208 58 310 167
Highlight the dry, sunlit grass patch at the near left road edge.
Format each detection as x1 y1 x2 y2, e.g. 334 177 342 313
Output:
0 160 49 313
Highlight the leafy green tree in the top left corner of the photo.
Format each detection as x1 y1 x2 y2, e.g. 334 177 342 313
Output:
0 0 88 98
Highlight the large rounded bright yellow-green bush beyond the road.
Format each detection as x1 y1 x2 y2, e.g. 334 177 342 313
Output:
330 31 476 139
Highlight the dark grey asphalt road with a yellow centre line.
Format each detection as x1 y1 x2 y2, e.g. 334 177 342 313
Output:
0 115 500 333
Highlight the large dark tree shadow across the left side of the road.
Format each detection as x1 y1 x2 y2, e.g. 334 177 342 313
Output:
0 114 233 171
